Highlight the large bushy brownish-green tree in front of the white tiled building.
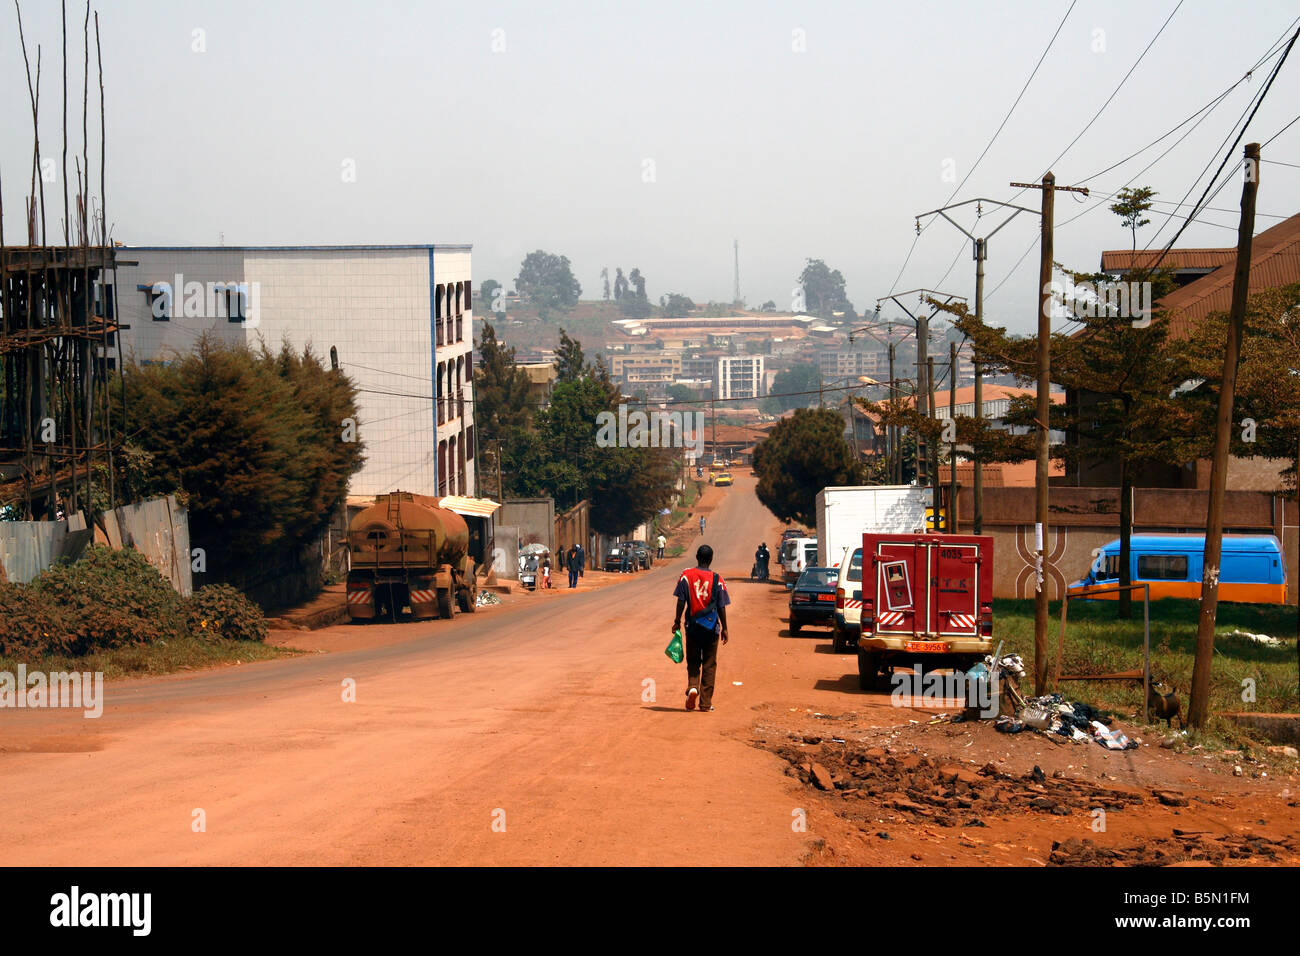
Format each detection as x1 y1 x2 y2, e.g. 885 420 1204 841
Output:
114 337 364 590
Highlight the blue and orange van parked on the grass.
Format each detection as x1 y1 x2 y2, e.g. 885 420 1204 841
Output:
1070 535 1287 604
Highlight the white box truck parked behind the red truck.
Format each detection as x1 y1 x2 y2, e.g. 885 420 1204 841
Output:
816 485 931 567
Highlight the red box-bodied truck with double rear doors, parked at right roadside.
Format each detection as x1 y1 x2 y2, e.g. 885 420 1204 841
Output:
858 533 993 691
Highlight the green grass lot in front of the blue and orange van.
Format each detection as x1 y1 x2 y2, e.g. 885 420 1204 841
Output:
993 598 1300 747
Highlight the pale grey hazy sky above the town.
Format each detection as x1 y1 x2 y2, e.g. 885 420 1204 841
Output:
0 0 1300 330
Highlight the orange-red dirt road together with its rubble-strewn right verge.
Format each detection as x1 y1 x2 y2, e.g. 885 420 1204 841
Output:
0 473 1300 865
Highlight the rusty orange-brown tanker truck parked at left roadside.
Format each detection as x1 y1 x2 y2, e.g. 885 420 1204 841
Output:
347 492 478 620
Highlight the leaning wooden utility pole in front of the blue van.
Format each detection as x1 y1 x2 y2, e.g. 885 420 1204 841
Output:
1187 143 1260 727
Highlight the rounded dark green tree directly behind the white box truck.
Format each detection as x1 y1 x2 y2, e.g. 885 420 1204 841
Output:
754 408 863 525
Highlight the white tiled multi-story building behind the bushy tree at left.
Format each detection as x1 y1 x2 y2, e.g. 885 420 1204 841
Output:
117 246 477 497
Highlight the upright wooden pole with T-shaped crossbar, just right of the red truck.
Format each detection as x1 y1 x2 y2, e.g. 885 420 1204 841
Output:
1011 172 1088 695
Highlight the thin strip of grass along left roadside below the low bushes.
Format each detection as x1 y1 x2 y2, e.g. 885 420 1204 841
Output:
0 637 299 680
